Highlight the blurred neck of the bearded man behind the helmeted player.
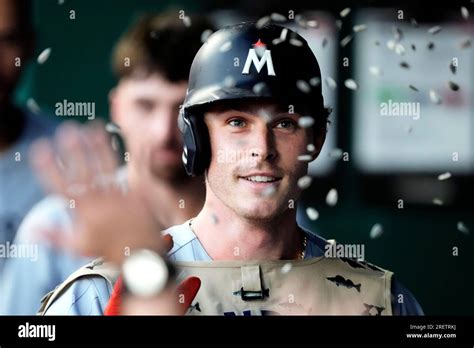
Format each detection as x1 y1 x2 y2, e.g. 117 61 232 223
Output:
127 166 205 227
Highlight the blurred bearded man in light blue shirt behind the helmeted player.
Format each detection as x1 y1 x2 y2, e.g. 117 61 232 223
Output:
2 11 212 314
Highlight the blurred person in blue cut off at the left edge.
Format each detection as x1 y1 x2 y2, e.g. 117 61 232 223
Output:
0 0 55 274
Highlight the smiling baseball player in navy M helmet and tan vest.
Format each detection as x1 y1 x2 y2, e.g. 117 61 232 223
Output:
36 23 423 315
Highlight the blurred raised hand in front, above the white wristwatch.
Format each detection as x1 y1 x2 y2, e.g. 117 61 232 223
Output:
31 122 166 263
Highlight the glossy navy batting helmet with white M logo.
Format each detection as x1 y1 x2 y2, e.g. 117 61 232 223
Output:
179 23 329 176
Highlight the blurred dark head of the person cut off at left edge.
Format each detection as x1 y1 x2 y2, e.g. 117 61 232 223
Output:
0 0 34 109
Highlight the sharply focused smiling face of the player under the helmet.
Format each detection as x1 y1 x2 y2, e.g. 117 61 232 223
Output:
205 104 311 221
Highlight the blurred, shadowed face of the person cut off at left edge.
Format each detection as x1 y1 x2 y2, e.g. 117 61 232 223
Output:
0 0 25 104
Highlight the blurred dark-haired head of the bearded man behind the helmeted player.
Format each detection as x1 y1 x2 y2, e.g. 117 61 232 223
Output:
110 11 211 181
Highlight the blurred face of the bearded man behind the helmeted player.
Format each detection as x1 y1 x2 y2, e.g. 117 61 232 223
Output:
111 74 187 180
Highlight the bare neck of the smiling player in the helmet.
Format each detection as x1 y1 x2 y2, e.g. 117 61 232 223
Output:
192 192 302 260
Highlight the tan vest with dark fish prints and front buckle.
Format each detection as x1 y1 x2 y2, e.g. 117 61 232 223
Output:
38 257 392 316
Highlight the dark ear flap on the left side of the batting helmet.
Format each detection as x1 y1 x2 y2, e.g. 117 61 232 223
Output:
178 109 211 176
